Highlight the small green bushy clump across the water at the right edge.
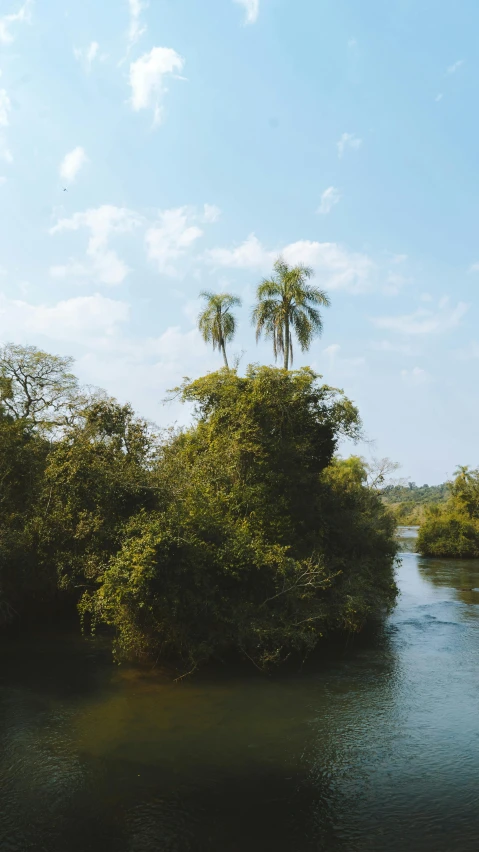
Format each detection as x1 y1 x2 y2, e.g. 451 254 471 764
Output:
418 467 479 559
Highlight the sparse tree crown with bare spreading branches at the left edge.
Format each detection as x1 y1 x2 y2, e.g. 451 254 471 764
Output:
0 343 80 429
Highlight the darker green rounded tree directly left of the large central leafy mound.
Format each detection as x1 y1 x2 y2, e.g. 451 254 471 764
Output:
37 399 157 589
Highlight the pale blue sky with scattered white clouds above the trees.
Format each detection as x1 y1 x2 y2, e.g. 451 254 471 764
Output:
0 0 479 484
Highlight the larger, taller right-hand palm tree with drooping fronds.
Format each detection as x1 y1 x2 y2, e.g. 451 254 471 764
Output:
252 257 330 370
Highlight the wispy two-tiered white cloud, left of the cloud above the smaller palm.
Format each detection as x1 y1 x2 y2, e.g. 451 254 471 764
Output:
50 204 143 286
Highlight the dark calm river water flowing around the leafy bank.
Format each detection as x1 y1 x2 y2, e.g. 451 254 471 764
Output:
0 529 479 852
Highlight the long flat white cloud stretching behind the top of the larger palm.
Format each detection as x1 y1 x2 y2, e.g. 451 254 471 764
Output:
205 234 374 293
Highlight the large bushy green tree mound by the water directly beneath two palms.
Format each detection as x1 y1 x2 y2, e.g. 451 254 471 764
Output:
81 367 395 671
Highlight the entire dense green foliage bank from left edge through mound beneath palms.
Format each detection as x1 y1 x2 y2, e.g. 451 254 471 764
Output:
0 344 396 670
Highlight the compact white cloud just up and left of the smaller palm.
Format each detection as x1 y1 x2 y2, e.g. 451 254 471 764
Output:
145 207 205 275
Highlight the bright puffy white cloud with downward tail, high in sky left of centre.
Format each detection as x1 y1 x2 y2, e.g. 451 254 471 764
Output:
130 47 185 124
